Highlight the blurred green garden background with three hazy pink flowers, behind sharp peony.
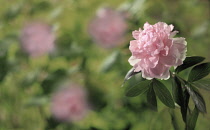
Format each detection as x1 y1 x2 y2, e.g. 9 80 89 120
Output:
0 0 210 130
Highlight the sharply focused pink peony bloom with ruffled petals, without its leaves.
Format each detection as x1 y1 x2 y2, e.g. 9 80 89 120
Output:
128 22 187 79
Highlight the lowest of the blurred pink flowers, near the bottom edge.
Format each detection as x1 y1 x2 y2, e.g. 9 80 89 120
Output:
51 85 89 121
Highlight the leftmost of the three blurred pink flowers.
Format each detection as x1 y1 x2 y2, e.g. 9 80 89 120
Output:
20 22 55 57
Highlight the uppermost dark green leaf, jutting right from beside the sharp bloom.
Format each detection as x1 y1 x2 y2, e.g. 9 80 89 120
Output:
175 56 205 73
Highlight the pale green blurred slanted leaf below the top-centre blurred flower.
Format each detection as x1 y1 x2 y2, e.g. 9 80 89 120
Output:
100 51 120 72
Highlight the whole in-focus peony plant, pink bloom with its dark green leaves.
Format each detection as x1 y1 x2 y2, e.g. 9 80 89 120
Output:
124 22 210 130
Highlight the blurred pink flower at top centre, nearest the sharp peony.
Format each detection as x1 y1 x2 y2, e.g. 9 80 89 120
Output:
89 8 127 48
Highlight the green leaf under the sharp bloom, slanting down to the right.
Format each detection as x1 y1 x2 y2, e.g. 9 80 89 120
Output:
153 79 175 108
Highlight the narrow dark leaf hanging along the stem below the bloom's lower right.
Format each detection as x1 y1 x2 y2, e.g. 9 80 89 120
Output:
172 76 184 107
